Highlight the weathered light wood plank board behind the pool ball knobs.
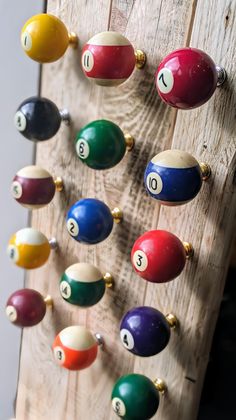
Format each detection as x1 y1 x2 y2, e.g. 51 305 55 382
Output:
17 0 236 420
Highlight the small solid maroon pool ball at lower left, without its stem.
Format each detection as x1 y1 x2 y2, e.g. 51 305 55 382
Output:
6 289 46 327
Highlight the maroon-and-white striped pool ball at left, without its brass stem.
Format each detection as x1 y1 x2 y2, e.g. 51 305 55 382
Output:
11 165 56 210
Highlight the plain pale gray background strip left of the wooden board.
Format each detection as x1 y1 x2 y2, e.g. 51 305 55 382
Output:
0 0 43 420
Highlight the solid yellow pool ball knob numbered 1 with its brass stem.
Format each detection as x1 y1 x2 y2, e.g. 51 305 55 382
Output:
21 13 78 63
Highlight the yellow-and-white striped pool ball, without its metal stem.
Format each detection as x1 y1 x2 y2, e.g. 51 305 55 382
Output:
7 228 50 269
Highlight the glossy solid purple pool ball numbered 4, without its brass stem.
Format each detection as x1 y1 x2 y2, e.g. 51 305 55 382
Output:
120 306 170 357
